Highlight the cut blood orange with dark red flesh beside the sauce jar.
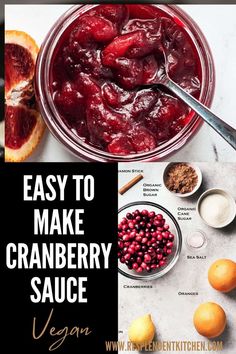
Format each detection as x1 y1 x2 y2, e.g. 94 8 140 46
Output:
4 31 45 162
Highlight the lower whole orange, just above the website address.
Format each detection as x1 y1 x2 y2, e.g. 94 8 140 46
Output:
193 302 226 338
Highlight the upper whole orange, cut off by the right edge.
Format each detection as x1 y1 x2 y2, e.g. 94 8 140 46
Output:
208 259 236 293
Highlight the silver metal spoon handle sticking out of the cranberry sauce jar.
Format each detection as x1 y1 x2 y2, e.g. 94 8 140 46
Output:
165 79 236 150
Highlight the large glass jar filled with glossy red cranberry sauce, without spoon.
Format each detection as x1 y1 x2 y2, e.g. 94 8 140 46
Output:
35 4 215 162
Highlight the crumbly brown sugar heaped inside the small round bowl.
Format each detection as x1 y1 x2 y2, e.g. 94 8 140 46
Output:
165 163 198 194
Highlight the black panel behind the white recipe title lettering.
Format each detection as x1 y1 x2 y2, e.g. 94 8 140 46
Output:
0 163 118 354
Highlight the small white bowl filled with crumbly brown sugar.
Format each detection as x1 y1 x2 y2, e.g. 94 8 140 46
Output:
163 162 202 197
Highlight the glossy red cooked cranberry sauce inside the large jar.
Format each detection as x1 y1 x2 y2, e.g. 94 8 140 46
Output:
50 5 201 155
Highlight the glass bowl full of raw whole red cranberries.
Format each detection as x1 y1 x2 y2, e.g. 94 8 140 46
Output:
118 202 182 280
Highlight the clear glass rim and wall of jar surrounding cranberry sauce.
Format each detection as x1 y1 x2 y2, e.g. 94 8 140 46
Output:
35 4 215 162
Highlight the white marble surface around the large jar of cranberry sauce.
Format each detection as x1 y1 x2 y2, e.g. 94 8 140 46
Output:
5 5 236 162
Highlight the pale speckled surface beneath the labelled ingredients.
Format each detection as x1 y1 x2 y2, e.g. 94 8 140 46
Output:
119 162 236 354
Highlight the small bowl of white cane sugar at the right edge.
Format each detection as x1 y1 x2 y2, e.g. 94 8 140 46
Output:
197 188 236 228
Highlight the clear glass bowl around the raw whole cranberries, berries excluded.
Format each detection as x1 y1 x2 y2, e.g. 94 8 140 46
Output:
118 201 182 280
